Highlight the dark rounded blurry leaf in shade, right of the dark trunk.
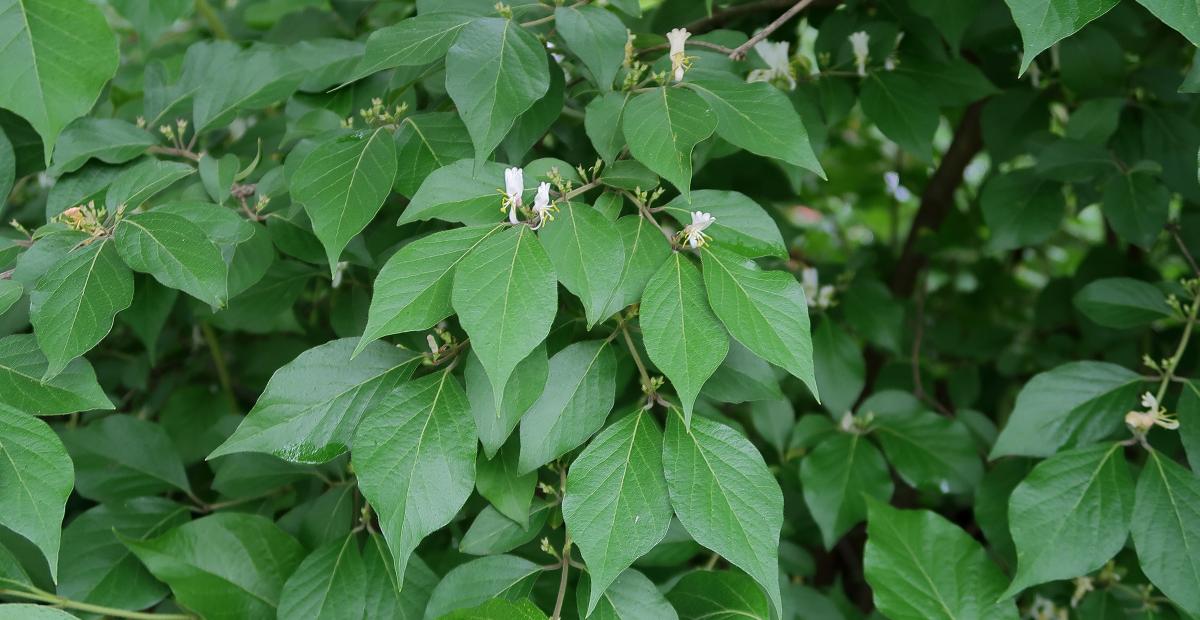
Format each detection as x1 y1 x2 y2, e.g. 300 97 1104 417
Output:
979 168 1067 251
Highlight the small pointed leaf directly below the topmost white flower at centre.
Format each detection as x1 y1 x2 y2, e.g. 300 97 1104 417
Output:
622 86 716 198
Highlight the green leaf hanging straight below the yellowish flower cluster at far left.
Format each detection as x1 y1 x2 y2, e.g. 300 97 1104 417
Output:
29 239 133 379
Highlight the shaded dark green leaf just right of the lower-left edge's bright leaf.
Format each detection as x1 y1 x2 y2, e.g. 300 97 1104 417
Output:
61 414 192 501
